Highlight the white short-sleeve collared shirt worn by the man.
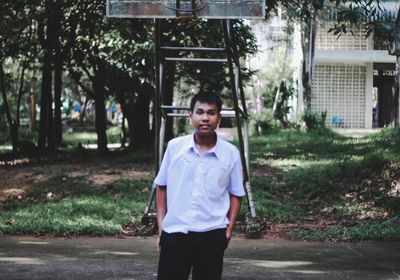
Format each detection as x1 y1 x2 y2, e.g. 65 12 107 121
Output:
154 134 245 233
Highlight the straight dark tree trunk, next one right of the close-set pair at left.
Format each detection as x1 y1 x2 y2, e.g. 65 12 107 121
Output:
93 66 108 155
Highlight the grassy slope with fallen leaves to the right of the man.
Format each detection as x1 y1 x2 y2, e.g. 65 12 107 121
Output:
251 130 400 240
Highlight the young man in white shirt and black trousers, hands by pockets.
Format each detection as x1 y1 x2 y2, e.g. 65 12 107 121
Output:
155 93 245 280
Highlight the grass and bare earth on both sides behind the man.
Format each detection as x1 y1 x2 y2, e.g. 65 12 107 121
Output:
0 129 400 240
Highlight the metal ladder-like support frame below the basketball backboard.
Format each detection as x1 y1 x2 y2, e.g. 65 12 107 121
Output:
144 19 256 218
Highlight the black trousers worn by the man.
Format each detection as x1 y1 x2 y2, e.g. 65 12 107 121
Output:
157 229 227 280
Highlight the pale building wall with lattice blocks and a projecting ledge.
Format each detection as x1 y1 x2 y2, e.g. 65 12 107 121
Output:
311 23 395 128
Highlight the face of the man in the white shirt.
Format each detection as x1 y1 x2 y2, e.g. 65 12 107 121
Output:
190 101 221 135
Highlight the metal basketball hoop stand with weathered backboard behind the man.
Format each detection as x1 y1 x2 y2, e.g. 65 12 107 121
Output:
106 0 265 224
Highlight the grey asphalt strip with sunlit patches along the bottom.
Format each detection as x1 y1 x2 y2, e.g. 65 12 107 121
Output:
0 236 400 280
